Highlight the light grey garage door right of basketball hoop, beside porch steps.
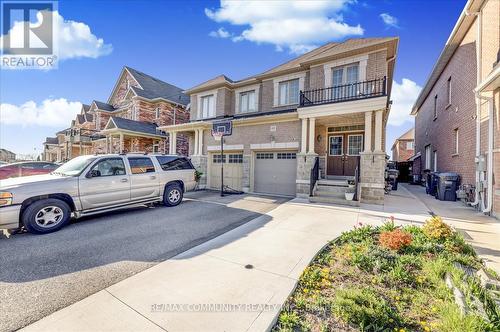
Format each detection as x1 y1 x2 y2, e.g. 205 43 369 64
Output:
254 152 297 196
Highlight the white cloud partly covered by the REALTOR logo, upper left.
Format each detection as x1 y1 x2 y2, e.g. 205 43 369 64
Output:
0 11 113 60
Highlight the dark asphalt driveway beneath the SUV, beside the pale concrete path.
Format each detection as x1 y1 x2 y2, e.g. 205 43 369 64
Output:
0 191 287 331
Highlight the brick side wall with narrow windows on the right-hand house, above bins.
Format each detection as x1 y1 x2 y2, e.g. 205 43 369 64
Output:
415 18 476 184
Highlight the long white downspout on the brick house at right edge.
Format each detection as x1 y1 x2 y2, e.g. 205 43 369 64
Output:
465 11 484 209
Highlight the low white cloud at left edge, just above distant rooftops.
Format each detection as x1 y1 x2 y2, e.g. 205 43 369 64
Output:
0 98 82 127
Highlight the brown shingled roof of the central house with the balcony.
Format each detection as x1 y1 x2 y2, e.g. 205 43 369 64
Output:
185 37 399 93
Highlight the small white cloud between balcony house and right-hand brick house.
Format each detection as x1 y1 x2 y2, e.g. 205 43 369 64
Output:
388 78 422 126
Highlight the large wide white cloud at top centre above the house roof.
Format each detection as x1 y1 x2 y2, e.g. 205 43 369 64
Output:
205 0 364 54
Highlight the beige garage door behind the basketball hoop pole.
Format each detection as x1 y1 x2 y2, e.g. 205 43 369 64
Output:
209 153 243 190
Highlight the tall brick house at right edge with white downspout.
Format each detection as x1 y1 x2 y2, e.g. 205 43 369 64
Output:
412 0 500 214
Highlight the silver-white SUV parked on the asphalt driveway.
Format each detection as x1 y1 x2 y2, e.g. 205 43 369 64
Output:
0 154 196 234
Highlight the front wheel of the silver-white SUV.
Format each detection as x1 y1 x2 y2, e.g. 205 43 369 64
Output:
21 198 71 234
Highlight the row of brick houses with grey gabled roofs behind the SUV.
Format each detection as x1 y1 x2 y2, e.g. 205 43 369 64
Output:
45 66 189 161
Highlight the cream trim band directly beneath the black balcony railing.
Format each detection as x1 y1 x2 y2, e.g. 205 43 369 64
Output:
297 96 387 119
